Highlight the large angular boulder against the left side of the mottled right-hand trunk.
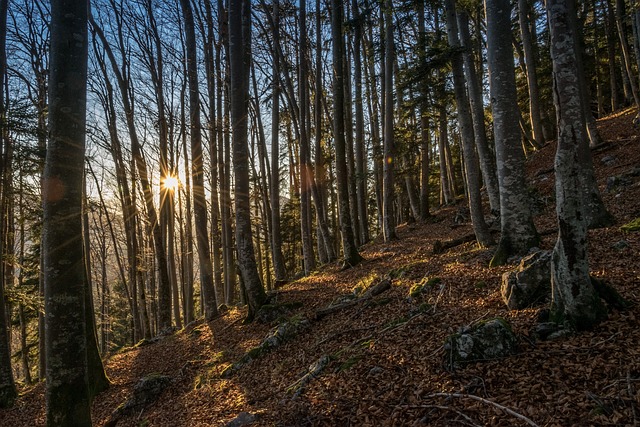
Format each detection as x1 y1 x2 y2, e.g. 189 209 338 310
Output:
500 251 551 310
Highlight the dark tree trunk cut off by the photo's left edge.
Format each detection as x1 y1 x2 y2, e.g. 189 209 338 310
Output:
0 0 18 408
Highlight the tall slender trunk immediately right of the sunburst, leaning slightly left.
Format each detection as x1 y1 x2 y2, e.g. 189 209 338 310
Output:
180 0 218 320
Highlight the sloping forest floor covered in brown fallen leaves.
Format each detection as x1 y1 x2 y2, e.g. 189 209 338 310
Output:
0 110 640 427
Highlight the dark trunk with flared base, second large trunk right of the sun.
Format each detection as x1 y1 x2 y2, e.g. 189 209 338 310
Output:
227 0 267 321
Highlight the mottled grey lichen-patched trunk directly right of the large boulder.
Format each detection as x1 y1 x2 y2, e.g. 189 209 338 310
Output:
546 0 606 330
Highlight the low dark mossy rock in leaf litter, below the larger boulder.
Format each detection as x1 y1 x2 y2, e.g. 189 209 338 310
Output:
444 318 518 371
